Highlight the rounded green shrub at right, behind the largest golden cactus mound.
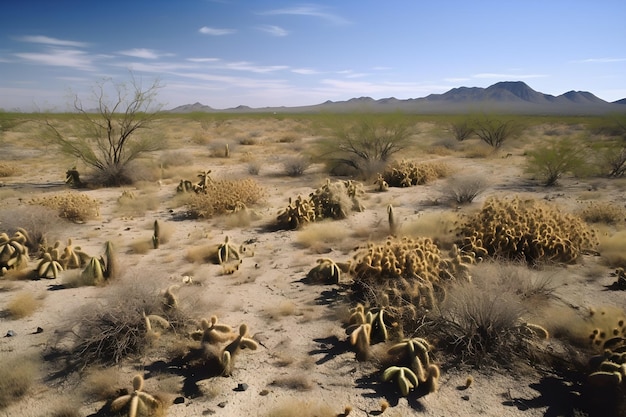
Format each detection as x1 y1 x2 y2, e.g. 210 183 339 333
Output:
526 138 586 186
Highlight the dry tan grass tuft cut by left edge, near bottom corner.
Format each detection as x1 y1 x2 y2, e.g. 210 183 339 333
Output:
0 355 39 410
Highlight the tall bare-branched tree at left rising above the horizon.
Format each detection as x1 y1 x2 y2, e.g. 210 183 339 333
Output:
45 74 164 186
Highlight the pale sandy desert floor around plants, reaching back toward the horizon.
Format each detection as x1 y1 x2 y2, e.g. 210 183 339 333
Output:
0 116 626 417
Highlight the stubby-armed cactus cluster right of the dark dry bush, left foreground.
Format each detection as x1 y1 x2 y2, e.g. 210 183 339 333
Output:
181 316 258 376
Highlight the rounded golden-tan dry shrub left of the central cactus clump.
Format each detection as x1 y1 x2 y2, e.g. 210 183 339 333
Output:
186 179 265 218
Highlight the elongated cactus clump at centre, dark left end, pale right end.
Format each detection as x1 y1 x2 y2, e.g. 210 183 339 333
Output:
276 179 365 230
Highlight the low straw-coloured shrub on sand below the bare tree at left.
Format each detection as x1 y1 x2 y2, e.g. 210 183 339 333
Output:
29 192 100 223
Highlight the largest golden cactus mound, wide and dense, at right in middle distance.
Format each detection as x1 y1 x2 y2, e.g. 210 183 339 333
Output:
457 197 597 264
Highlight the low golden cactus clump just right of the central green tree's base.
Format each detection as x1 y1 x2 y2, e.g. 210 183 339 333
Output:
378 160 448 187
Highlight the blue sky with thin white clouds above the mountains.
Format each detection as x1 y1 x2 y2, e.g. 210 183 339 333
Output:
0 0 626 111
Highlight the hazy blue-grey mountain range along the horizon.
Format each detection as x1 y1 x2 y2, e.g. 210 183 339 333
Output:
170 81 626 115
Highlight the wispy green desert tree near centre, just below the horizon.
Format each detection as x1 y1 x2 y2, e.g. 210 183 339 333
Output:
317 113 414 178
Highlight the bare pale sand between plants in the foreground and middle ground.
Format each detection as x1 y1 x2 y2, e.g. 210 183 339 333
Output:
0 118 625 417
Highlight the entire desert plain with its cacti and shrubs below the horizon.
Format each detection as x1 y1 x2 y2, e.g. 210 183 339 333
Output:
0 101 626 417
